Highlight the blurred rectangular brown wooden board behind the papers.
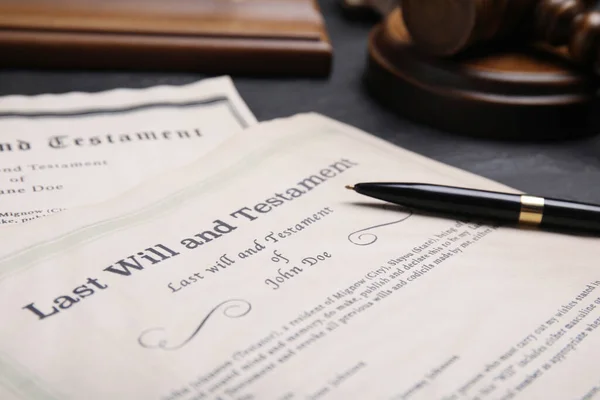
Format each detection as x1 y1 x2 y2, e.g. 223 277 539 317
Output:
0 0 332 76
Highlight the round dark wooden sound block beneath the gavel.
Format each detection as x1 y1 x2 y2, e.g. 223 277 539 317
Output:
366 9 600 140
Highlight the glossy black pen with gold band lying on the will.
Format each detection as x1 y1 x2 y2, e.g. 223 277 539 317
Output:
346 182 600 232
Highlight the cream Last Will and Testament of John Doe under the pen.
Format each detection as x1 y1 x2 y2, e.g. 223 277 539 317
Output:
0 115 600 400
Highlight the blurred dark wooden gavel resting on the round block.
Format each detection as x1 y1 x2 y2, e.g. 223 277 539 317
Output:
402 0 600 70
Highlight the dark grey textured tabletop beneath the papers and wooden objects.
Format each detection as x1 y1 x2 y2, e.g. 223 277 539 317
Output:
0 0 600 203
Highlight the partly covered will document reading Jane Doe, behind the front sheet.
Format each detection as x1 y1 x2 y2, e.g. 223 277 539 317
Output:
0 77 256 226
